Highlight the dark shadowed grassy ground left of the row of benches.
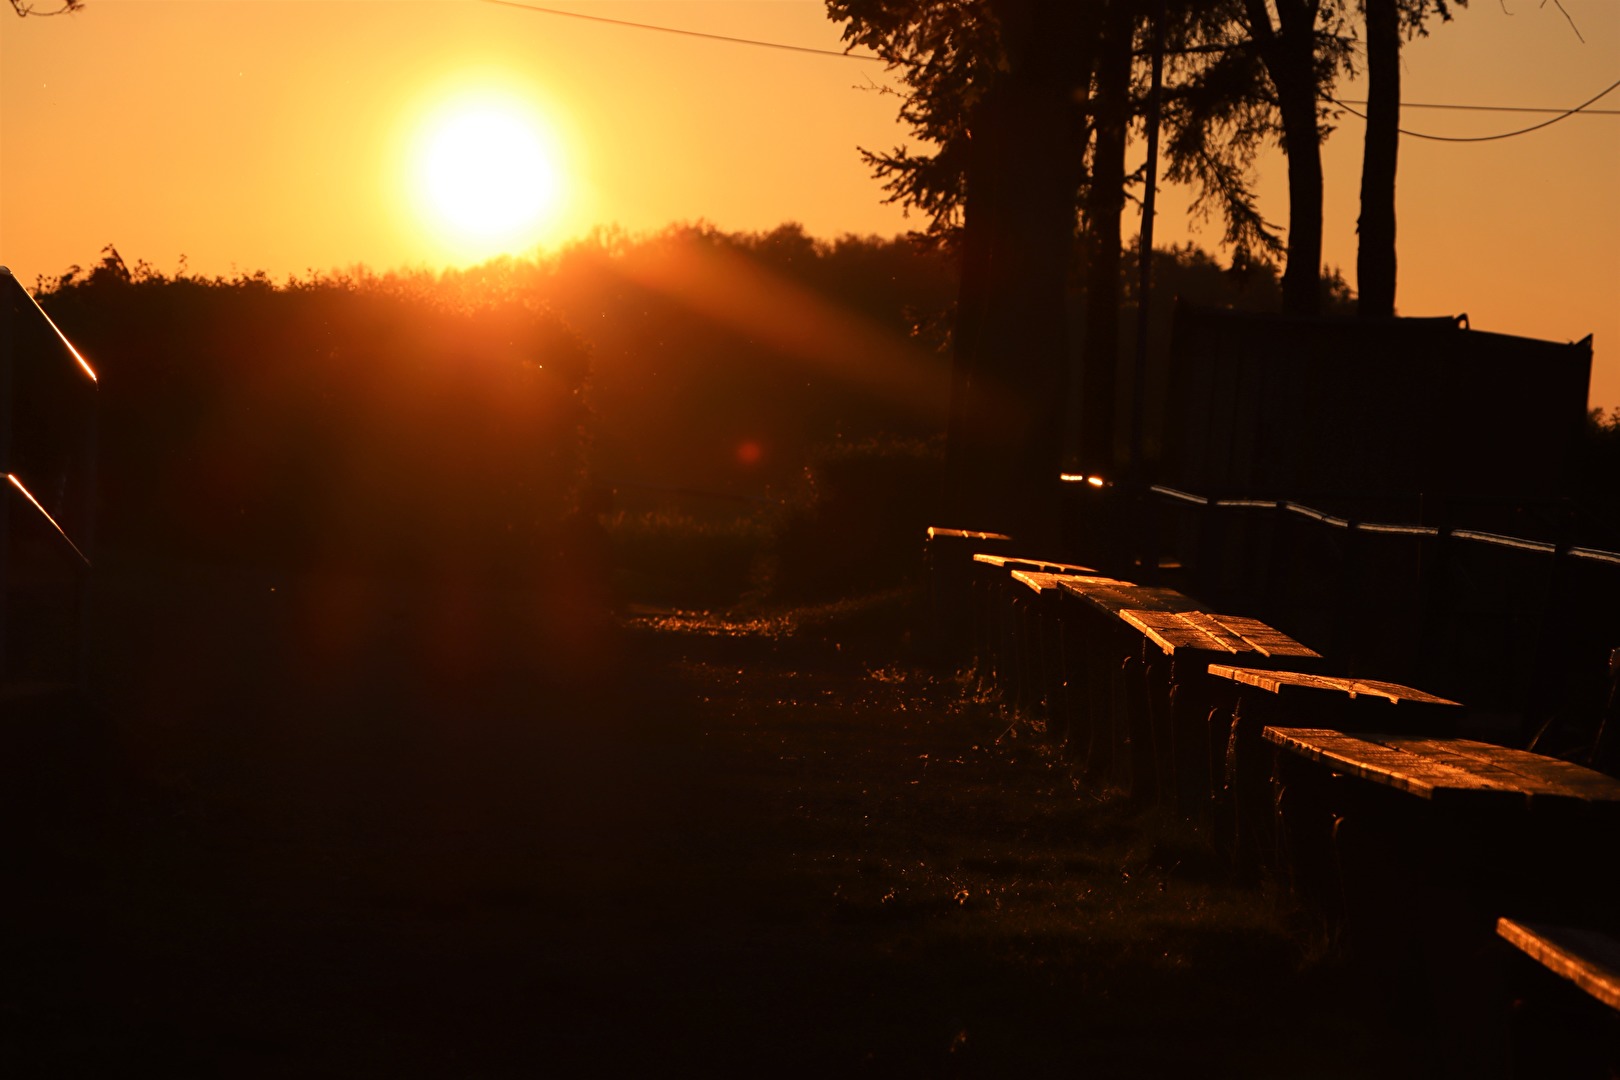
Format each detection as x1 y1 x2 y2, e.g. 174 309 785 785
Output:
0 568 1435 1077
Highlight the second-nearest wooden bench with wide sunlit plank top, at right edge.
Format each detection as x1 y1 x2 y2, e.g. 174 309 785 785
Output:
1262 725 1620 965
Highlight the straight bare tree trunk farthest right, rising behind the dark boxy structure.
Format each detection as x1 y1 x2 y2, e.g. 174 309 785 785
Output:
1356 0 1401 319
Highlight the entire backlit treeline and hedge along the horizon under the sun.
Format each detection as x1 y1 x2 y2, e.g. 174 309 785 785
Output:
41 225 1343 582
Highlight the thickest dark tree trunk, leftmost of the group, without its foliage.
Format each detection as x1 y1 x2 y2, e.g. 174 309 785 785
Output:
946 0 1079 546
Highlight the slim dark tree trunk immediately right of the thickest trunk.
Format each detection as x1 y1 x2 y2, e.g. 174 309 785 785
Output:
1081 0 1132 476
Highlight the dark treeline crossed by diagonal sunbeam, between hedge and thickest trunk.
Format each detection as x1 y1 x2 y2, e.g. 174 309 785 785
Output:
446 225 956 495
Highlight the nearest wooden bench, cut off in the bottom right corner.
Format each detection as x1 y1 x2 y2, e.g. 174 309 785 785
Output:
1497 918 1620 1077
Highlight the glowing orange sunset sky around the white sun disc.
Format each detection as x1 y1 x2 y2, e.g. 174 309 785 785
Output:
0 0 1620 408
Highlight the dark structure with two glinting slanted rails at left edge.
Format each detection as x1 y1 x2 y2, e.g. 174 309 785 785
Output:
0 267 97 683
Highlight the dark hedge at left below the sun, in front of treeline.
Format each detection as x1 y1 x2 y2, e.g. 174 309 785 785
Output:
41 249 588 572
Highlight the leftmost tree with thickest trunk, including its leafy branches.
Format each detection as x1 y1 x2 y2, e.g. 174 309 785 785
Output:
828 0 1102 542
